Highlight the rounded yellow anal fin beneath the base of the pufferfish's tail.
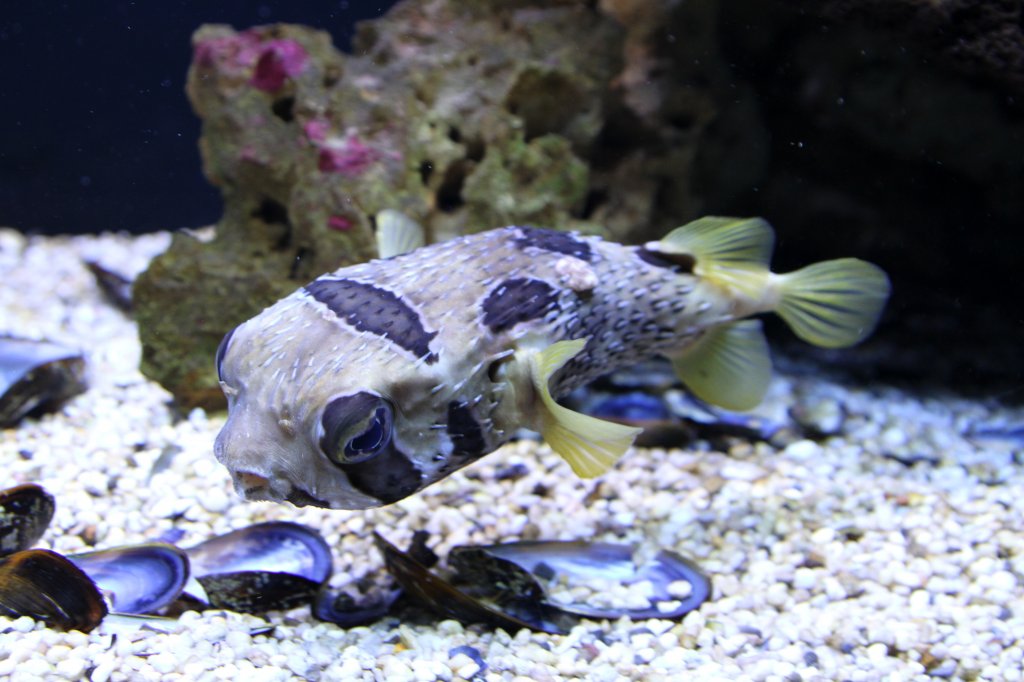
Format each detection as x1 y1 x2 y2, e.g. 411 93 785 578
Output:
672 319 771 410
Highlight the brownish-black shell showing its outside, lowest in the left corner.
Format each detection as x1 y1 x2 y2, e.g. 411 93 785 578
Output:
0 550 106 632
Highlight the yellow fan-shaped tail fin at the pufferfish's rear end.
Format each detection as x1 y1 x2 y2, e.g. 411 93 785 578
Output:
775 258 889 348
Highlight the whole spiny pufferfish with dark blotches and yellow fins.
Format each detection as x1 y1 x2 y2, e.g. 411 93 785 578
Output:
214 211 889 509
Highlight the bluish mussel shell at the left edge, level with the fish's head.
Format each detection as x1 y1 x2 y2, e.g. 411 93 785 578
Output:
0 337 85 428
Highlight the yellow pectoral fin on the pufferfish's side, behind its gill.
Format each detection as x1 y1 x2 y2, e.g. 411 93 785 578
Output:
530 339 643 478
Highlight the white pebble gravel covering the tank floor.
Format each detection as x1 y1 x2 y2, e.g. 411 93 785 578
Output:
0 230 1024 682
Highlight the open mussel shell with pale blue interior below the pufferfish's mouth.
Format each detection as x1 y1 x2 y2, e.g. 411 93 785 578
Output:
185 521 333 613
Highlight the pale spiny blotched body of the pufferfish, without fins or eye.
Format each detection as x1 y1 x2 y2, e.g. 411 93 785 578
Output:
215 226 738 509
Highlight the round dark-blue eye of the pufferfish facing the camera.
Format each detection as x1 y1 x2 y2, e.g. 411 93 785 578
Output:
319 392 394 465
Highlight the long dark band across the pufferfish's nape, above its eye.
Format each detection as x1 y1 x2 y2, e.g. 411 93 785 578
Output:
305 280 437 364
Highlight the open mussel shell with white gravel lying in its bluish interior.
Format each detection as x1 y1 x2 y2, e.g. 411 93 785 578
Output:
449 541 711 620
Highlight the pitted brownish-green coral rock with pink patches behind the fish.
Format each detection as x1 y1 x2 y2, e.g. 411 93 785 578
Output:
134 0 729 408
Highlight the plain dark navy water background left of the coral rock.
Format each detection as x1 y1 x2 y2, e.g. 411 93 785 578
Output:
0 0 394 233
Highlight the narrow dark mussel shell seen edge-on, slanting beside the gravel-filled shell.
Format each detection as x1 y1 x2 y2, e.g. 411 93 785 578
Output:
374 532 571 634
